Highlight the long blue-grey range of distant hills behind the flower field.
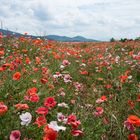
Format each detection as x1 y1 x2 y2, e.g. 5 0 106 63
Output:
0 29 99 42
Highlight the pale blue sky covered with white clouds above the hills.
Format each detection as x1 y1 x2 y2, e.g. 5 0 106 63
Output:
0 0 140 40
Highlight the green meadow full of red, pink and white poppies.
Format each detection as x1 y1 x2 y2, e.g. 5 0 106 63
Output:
0 34 140 140
